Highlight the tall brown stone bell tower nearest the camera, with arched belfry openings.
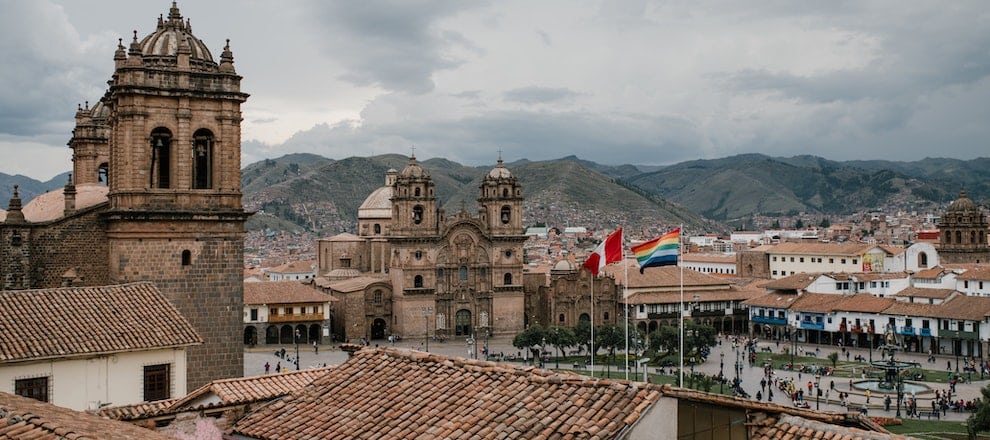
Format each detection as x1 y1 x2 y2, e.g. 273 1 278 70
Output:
102 2 248 389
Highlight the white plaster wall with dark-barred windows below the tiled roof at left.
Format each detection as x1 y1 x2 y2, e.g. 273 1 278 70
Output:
0 348 186 411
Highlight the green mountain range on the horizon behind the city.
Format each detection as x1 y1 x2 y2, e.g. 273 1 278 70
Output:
0 154 990 236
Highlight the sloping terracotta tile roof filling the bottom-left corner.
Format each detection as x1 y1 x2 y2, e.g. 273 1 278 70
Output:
0 392 174 440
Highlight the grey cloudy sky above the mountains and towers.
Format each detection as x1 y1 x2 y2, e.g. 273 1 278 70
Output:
0 0 990 179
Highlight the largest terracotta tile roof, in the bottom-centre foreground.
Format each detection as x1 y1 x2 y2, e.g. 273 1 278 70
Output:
232 348 661 439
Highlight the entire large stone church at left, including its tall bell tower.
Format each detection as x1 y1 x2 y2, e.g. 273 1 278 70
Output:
0 2 248 388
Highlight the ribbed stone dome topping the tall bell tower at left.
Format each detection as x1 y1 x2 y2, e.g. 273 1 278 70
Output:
139 2 216 65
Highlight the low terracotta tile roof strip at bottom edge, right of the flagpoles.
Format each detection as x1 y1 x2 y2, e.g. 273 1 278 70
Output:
748 414 911 440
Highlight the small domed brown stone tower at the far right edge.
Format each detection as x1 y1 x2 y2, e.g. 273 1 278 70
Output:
938 191 990 264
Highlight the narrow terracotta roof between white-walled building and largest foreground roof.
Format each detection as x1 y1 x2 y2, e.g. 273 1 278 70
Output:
96 366 336 420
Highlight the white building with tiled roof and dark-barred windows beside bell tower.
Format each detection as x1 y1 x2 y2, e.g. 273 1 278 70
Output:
0 282 203 410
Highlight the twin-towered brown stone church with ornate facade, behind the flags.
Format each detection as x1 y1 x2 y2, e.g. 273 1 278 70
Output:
316 157 530 340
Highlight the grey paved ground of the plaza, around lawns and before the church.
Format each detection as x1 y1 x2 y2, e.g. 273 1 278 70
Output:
244 337 990 420
